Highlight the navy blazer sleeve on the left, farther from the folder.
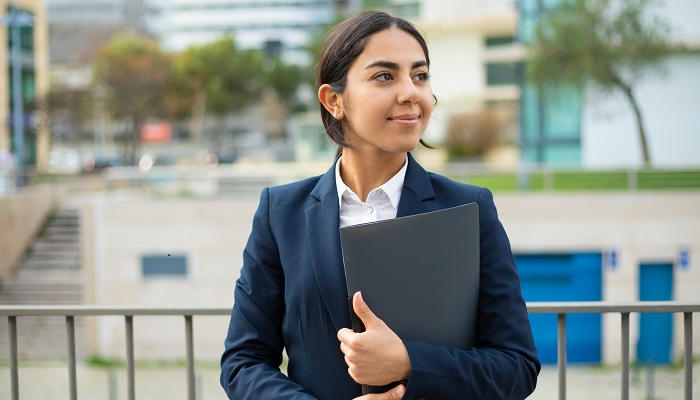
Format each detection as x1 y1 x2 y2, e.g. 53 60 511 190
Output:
221 188 314 400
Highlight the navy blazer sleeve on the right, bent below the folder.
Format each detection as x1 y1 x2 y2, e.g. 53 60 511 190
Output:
404 189 540 400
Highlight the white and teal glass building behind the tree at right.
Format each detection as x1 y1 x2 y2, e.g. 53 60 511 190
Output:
518 0 700 168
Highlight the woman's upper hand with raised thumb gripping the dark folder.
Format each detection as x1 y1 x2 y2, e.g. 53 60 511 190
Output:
338 292 411 386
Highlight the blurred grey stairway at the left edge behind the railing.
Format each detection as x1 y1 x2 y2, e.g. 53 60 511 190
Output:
0 208 84 360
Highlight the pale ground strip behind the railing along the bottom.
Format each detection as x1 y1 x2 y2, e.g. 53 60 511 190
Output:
0 363 700 400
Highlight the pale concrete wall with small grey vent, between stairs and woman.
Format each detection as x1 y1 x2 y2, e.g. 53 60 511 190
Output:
82 196 258 360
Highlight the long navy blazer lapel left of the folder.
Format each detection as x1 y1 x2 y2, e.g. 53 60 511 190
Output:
306 166 350 331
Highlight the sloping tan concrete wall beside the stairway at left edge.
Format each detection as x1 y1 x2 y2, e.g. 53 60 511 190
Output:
0 185 56 278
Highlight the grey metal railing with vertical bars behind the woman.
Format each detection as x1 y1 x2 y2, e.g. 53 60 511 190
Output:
0 301 700 400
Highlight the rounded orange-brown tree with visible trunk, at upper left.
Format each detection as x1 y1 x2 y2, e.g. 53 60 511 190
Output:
95 34 170 163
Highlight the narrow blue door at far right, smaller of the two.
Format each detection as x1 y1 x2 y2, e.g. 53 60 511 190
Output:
637 264 673 364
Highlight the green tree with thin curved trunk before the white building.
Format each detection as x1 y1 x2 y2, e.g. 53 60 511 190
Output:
528 0 673 166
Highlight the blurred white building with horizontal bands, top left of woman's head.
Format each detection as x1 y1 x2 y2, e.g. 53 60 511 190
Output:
147 0 353 64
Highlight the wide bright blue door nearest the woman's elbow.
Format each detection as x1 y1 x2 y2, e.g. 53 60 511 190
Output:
515 253 602 364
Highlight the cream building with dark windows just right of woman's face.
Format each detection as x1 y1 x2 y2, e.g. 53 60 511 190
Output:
412 0 522 166
